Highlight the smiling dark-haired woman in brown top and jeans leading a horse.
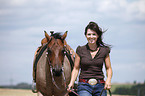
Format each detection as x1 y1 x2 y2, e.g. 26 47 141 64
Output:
68 22 112 96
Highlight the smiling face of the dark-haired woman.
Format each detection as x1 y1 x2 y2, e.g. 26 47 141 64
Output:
86 29 99 44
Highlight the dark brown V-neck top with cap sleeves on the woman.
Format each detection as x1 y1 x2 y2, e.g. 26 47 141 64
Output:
76 44 110 79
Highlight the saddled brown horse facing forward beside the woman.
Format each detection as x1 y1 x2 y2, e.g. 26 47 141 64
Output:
36 31 73 96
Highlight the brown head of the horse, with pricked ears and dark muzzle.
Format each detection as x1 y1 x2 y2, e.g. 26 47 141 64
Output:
45 31 67 76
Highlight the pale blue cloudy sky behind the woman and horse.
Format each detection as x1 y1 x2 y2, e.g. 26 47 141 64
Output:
0 0 145 85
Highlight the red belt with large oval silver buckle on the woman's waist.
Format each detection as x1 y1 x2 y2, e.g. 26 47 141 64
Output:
79 79 105 85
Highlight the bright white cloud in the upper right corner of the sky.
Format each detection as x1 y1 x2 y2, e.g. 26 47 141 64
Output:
95 0 145 21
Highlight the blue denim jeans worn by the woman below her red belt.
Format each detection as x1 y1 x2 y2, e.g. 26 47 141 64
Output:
77 82 107 96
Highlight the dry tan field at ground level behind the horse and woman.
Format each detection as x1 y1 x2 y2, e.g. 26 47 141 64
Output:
0 88 135 96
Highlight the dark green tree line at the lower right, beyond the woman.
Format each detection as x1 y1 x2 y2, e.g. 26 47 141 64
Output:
113 83 145 96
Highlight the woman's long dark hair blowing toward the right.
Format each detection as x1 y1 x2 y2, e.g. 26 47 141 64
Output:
85 22 110 49
